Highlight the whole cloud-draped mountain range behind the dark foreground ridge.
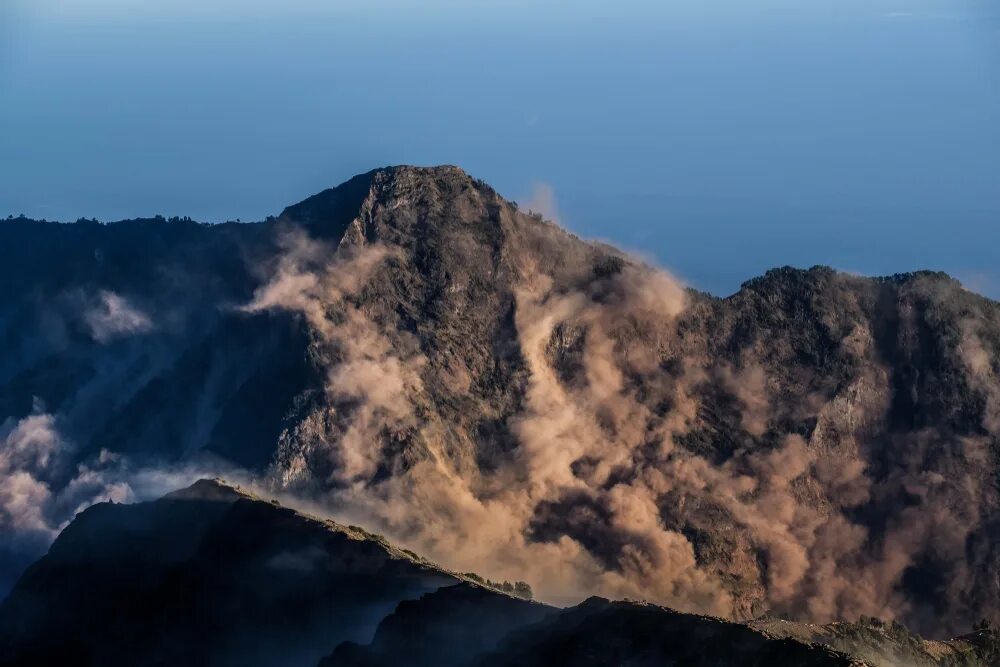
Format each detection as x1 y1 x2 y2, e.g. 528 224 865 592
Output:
0 167 1000 637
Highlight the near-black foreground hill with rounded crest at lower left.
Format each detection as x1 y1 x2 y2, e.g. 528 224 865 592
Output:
0 480 459 665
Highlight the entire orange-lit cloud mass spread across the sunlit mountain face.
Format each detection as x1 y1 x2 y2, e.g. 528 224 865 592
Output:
247 226 995 636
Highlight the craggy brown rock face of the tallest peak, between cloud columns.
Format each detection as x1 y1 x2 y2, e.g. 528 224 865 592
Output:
268 167 608 481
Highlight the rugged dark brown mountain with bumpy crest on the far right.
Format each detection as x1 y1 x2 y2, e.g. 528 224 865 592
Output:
667 269 1000 632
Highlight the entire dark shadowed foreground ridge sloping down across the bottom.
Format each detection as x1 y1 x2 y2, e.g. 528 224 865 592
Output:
0 480 1000 667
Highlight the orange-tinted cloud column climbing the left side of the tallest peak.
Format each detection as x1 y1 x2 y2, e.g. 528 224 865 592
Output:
244 230 424 486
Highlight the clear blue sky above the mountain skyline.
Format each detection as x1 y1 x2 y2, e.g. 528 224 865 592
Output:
0 0 1000 297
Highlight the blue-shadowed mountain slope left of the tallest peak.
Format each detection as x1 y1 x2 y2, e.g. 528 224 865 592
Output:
0 218 306 465
